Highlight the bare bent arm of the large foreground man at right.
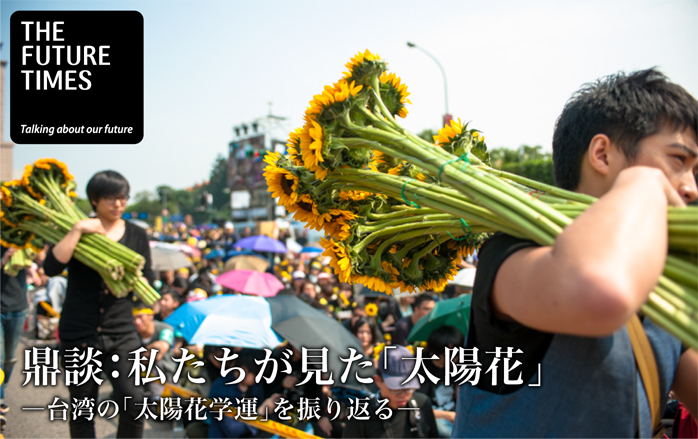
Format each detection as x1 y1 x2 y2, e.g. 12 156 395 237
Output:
492 167 681 336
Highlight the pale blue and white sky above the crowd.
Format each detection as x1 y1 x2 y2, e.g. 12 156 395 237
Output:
0 0 698 196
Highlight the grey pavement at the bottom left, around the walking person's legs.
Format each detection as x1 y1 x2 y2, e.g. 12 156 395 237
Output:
3 334 184 438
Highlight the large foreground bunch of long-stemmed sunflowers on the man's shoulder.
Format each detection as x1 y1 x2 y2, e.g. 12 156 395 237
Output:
265 50 698 347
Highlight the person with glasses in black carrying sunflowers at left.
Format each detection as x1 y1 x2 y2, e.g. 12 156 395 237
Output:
44 171 154 437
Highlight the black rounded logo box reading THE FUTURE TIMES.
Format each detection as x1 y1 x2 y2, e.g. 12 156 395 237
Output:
9 11 143 144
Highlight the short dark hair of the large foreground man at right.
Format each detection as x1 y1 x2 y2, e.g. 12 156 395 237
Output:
553 68 698 190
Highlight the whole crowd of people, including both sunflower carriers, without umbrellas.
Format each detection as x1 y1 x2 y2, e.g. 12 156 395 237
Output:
0 69 698 437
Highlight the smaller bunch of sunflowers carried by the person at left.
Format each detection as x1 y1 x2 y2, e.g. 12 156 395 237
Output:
0 158 160 304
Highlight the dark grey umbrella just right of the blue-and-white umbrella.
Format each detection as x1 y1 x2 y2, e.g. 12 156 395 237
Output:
267 294 375 390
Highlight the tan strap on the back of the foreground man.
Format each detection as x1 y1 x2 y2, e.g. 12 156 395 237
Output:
626 314 662 437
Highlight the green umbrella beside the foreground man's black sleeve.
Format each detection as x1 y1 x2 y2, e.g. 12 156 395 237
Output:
407 294 473 342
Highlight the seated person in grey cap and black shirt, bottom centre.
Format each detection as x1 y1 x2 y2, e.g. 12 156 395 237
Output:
343 346 439 438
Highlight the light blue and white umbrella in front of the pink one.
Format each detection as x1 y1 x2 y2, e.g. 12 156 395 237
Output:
165 294 283 349
